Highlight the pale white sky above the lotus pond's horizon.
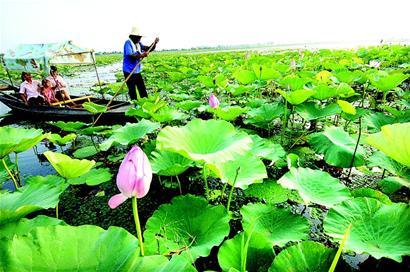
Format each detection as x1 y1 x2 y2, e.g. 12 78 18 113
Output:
0 0 410 52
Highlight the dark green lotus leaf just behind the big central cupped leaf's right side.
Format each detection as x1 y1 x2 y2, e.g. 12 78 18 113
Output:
244 103 285 128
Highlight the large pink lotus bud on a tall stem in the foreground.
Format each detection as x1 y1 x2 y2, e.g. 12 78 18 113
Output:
108 145 152 209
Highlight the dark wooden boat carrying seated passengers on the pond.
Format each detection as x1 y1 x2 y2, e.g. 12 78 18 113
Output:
0 86 131 123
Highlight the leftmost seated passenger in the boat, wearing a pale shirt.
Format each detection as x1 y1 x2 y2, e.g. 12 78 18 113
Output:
19 72 44 106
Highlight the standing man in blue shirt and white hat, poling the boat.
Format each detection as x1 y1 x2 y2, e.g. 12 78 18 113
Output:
122 27 159 100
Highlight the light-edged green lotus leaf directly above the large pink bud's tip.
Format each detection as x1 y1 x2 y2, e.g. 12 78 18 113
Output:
100 119 160 151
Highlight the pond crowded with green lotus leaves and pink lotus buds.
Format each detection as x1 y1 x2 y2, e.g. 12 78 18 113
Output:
0 45 410 271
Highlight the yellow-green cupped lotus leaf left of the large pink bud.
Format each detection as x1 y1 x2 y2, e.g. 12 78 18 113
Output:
44 151 95 179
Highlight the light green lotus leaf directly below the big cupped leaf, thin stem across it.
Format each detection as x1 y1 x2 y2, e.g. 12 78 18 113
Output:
207 152 268 189
